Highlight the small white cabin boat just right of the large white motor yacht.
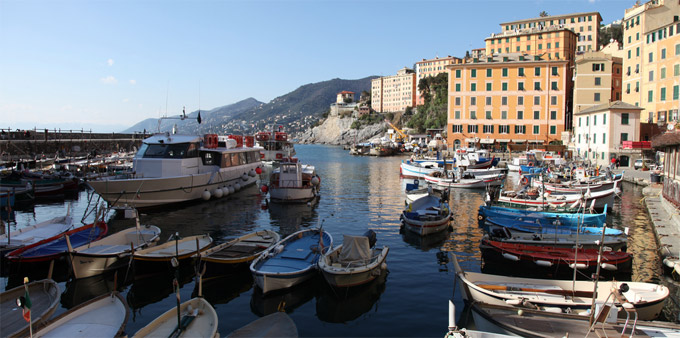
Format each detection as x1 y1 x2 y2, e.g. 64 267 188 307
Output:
268 158 321 203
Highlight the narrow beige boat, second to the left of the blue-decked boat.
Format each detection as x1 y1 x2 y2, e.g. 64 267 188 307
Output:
132 234 213 273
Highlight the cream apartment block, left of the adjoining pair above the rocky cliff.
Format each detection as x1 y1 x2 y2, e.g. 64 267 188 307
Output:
371 67 417 113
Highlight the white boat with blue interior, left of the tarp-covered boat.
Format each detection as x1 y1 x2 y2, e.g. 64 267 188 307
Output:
250 228 333 294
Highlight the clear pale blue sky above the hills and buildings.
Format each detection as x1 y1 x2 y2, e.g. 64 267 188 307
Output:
0 0 635 132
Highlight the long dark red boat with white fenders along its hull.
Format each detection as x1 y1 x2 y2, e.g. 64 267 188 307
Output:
479 239 632 272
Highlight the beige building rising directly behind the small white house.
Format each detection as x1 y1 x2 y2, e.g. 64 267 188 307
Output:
573 51 623 113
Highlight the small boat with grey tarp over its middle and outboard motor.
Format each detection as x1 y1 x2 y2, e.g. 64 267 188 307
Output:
319 230 390 288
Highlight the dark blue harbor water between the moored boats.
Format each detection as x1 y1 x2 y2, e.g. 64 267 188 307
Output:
0 145 677 337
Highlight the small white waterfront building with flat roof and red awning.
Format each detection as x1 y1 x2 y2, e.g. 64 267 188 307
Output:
573 101 650 167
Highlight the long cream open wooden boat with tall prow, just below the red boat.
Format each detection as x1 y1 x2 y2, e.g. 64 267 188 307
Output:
453 254 670 320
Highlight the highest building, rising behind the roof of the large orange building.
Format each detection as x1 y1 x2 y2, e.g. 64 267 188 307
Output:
496 12 602 55
